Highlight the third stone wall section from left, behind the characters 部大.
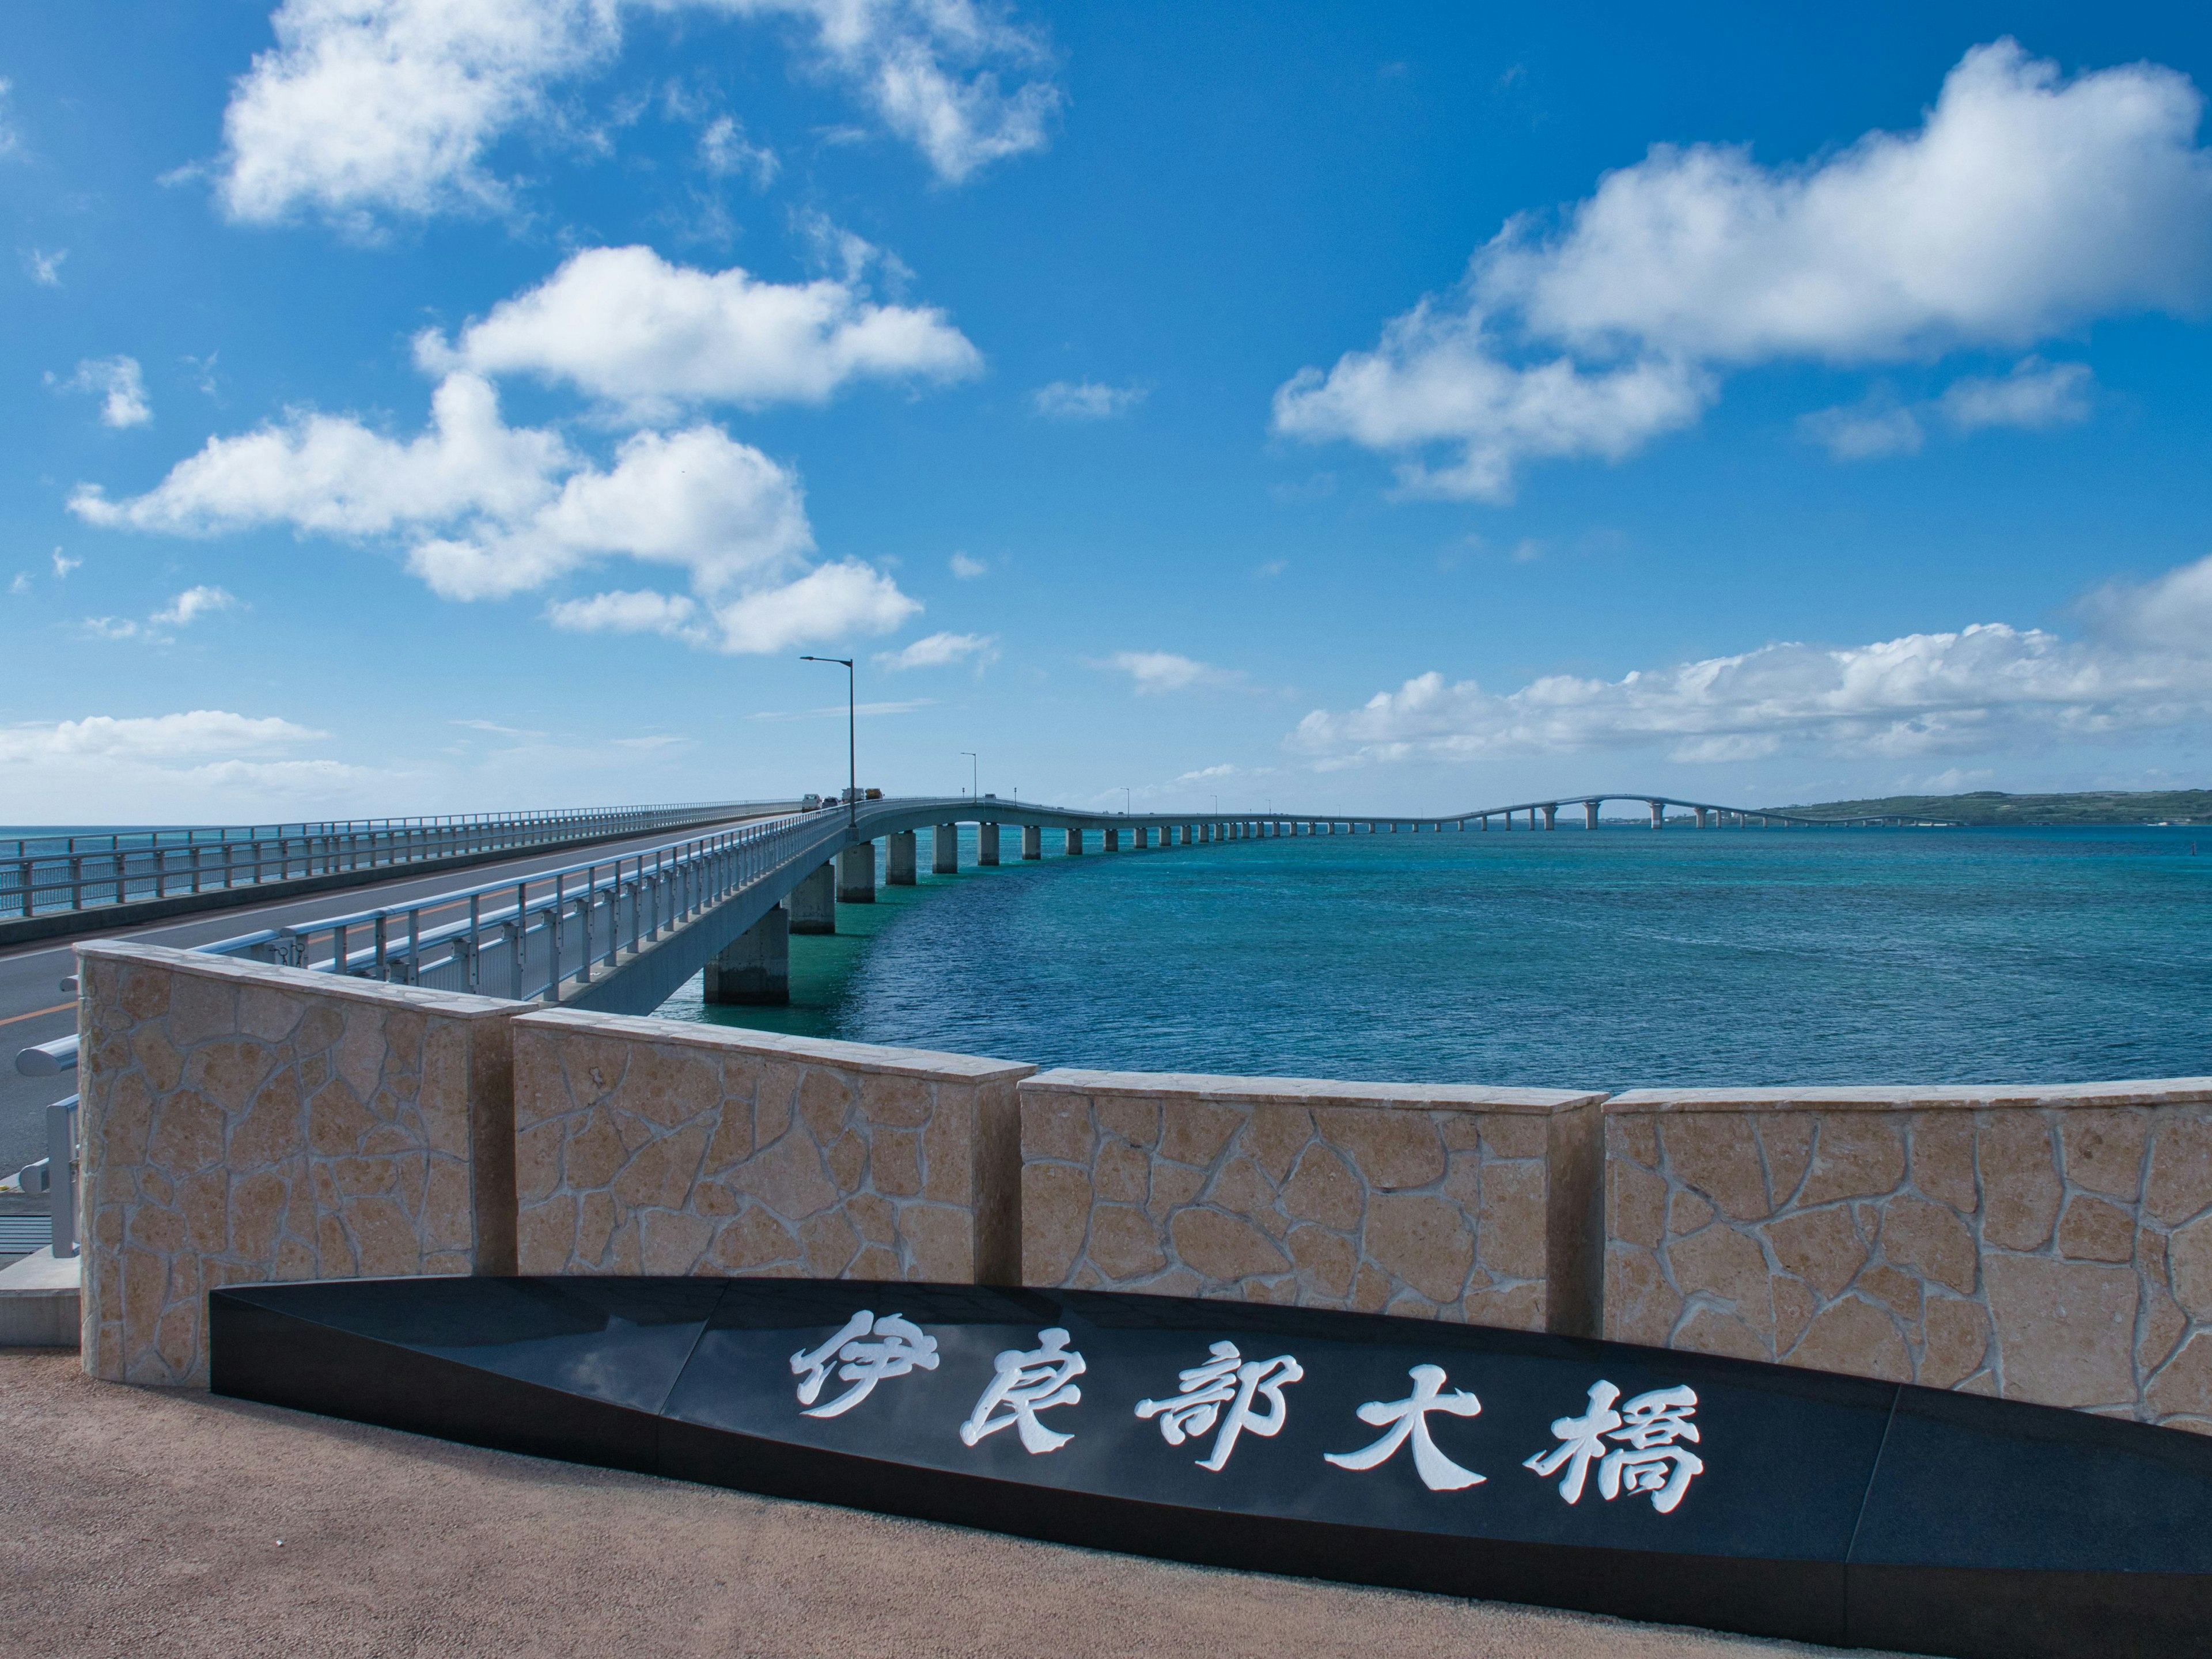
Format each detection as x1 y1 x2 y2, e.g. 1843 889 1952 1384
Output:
1022 1071 1604 1332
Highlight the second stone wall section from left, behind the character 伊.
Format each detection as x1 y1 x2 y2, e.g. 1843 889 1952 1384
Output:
513 1011 1035 1283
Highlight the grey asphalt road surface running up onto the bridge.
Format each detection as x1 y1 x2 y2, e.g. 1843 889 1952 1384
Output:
0 819 791 1214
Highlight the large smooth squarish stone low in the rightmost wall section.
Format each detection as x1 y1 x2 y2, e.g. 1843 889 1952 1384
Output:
1982 1254 2137 1404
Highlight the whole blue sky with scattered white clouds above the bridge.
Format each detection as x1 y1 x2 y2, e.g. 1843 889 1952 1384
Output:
0 0 2212 823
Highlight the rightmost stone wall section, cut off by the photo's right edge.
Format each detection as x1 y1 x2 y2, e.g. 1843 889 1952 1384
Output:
1604 1092 2212 1431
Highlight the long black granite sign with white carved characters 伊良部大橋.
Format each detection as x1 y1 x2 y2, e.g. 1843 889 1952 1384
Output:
210 1279 2212 1659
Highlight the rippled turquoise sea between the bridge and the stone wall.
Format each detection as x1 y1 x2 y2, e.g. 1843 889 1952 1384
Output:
664 827 2212 1088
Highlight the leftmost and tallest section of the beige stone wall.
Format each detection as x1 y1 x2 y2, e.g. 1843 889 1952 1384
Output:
77 945 520 1385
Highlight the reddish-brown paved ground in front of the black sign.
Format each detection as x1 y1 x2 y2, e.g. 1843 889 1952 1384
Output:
0 1349 1902 1659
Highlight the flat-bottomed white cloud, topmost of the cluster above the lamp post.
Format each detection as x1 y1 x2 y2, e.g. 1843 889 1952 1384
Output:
416 248 982 416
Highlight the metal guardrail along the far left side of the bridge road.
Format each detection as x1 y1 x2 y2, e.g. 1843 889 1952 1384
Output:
0 801 783 916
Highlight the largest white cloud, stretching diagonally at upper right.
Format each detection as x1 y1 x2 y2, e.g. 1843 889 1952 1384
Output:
1274 40 2212 500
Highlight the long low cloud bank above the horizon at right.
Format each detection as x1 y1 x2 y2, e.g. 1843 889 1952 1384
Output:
1287 558 2212 767
